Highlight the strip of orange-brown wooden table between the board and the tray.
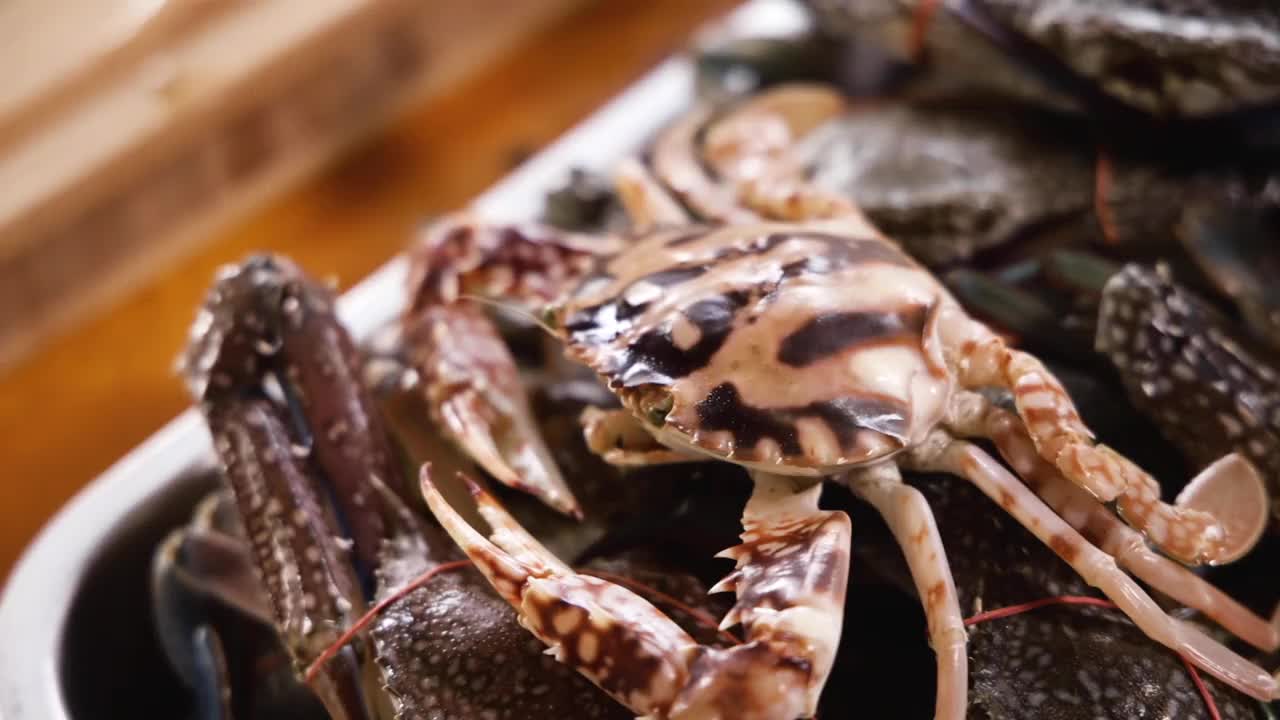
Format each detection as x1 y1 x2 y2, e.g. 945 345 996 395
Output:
0 0 737 577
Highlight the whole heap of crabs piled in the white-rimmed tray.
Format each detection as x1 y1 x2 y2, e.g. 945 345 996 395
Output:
154 0 1280 720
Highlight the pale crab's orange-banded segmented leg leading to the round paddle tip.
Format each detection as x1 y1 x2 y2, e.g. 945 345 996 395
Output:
943 316 1260 564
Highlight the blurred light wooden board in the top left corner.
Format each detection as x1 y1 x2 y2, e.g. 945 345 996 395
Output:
0 0 584 368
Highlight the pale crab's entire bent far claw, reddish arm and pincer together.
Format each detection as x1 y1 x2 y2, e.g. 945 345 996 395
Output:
402 215 606 518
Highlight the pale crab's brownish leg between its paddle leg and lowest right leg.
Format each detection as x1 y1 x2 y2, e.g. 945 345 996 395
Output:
967 400 1280 652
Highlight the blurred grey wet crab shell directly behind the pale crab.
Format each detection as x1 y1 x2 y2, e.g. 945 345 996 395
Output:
795 104 1097 266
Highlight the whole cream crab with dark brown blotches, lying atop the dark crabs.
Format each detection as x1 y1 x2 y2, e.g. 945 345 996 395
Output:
406 103 1280 720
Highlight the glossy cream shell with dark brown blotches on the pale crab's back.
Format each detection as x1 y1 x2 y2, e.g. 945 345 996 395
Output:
557 222 952 475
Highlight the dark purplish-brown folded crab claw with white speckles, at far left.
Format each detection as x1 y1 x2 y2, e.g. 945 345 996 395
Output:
180 255 413 719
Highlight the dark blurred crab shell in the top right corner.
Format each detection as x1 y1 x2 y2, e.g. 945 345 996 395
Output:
804 0 1280 118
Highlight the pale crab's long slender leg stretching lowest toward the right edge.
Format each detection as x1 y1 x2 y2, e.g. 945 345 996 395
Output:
908 432 1277 701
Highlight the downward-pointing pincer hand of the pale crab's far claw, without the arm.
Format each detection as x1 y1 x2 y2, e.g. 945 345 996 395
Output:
404 304 582 519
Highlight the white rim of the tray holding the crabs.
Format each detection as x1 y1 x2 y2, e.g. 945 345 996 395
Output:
0 0 805 720
